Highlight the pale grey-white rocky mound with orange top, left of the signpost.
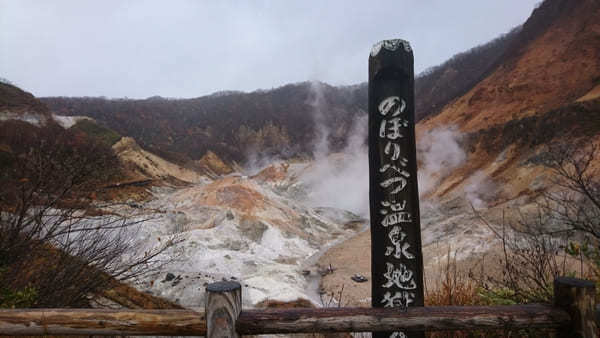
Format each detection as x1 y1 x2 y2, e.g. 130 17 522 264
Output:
130 163 365 308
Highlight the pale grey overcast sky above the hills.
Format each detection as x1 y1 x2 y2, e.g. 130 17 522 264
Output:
0 0 540 98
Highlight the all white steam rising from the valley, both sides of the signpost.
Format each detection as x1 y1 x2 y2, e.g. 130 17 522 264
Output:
241 81 494 219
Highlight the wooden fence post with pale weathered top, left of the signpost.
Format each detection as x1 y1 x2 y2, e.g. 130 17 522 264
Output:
205 282 242 338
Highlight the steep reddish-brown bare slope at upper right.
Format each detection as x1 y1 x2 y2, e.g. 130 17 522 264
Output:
417 0 600 199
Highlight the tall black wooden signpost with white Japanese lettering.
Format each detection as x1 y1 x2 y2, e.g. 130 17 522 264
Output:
369 39 424 338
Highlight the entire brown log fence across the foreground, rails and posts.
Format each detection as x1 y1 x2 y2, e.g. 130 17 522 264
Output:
0 278 598 338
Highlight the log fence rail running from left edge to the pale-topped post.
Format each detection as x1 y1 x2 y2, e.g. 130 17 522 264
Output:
0 309 206 336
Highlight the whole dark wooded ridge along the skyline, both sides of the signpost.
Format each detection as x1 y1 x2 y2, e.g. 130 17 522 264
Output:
42 16 520 164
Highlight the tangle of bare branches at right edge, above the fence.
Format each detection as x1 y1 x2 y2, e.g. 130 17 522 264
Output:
479 142 600 303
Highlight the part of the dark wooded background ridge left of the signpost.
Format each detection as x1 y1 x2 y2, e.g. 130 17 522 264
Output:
43 83 366 163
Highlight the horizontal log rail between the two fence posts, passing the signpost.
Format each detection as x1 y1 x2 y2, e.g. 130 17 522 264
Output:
236 304 571 335
